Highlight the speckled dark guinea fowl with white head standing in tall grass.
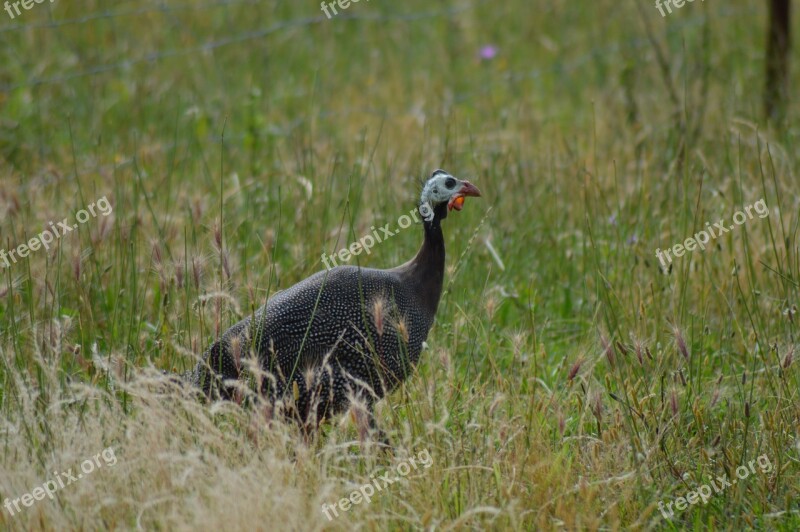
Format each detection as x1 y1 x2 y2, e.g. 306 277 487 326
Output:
189 170 481 440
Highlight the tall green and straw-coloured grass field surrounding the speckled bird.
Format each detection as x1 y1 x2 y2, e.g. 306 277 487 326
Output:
0 0 800 530
